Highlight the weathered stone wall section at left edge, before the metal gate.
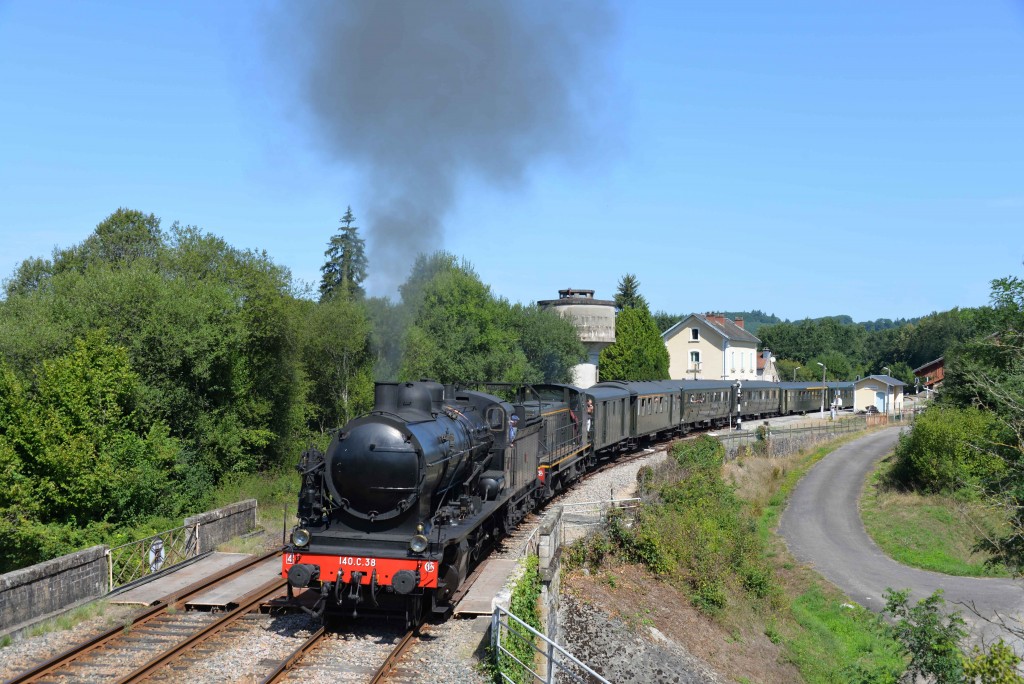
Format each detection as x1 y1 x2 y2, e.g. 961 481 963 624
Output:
0 546 109 634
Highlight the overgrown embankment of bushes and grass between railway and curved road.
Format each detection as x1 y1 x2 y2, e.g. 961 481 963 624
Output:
565 435 905 682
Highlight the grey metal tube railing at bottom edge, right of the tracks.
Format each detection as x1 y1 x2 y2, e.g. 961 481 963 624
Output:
490 605 610 684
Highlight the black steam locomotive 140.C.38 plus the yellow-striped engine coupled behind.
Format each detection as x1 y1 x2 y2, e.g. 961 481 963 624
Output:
283 382 587 624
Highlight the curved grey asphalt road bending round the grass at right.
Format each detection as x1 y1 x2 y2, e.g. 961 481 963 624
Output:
779 428 1024 653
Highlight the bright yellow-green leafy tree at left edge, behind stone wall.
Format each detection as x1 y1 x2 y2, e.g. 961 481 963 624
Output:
0 330 181 571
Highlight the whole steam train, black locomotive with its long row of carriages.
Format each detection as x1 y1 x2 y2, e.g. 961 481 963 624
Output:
282 380 853 625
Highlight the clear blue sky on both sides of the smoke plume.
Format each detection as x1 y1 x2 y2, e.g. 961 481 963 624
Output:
0 0 1024 320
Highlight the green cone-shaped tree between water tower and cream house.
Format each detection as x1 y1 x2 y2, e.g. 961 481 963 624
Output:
598 307 669 380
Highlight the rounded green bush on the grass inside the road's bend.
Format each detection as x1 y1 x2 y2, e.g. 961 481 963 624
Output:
892 407 1006 493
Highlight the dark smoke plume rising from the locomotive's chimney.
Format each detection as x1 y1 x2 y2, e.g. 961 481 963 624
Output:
274 0 613 291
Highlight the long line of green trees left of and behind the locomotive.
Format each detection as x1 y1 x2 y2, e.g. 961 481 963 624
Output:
0 208 584 572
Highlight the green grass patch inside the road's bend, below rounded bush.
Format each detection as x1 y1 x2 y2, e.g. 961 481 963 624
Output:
860 460 1010 578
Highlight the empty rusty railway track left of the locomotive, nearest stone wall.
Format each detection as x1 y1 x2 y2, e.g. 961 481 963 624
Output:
5 551 285 684
